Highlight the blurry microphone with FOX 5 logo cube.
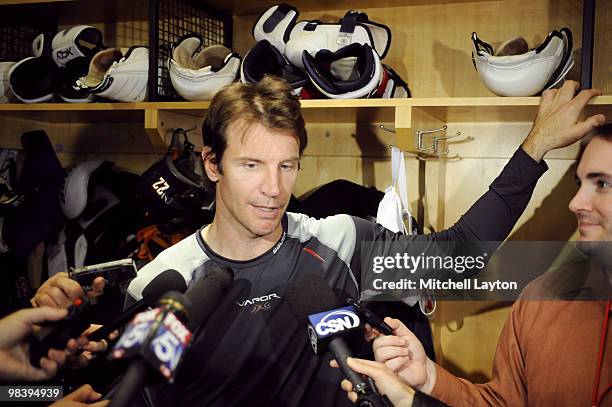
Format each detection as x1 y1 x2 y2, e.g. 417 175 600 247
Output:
110 267 234 407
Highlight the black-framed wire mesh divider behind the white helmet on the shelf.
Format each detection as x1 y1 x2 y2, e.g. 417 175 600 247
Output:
149 0 232 101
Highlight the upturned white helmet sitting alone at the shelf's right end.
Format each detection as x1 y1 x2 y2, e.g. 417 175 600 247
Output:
472 28 574 96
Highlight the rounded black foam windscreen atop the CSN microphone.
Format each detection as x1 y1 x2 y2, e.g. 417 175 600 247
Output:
285 271 341 322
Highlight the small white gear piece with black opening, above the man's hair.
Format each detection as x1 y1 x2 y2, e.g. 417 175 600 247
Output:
253 3 300 53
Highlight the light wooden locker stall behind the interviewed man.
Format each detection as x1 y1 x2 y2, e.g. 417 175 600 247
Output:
0 0 612 381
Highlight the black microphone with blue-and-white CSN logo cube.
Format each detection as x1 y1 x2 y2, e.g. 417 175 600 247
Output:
285 272 390 407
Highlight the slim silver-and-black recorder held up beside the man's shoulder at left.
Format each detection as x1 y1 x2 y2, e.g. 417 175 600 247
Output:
68 259 137 291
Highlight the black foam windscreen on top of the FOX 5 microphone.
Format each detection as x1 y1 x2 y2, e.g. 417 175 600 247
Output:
185 265 234 332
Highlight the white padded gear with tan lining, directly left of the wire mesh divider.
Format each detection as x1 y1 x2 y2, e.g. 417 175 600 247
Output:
75 46 149 102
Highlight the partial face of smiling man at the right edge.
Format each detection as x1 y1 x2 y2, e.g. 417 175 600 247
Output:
569 137 612 241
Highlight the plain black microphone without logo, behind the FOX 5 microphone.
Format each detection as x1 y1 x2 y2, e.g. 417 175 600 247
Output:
87 269 187 341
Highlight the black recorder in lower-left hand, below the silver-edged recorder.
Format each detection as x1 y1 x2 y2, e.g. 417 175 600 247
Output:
29 298 92 367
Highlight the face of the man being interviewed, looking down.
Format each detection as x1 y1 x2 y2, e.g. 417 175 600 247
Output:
207 121 299 238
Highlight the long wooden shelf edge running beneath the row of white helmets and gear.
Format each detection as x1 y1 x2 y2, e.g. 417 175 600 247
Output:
0 95 612 122
